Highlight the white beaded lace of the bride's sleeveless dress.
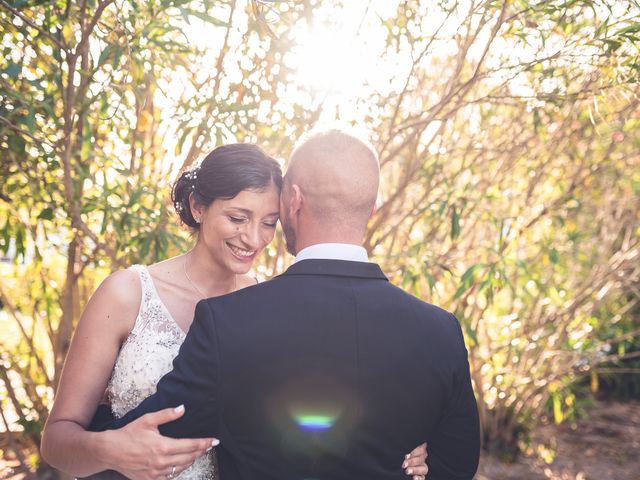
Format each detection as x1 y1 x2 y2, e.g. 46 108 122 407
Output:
107 265 218 480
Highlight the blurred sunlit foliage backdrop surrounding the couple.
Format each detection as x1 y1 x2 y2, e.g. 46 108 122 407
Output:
0 0 640 478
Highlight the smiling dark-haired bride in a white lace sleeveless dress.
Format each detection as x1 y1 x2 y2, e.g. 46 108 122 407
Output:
41 144 427 480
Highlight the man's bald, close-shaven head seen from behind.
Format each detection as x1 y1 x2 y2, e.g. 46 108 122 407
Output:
285 130 380 251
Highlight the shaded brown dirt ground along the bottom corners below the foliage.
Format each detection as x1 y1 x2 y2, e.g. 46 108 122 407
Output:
0 402 640 480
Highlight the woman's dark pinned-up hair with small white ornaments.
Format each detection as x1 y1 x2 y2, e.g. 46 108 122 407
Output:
171 143 282 230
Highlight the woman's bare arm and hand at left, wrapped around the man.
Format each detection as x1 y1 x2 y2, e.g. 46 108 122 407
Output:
41 270 213 479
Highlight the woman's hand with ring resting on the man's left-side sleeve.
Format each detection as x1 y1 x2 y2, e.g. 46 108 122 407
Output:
103 406 220 480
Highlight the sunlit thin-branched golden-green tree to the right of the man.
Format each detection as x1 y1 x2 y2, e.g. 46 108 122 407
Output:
356 2 640 455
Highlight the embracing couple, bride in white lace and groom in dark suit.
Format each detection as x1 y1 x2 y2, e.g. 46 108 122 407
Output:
42 130 480 480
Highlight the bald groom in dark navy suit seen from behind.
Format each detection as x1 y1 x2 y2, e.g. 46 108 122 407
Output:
95 130 480 480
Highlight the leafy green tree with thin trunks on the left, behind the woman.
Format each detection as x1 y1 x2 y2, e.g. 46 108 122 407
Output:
0 0 309 472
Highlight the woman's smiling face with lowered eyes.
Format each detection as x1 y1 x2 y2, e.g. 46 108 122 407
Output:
194 183 280 274
